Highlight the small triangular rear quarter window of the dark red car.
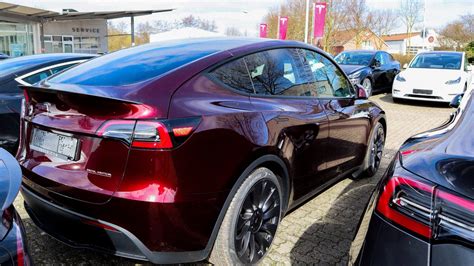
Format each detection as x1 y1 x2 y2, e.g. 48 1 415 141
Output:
211 59 254 93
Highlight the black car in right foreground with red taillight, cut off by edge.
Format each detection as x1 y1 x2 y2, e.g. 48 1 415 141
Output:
350 91 474 265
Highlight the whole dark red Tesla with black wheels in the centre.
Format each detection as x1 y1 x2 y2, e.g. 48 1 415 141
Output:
18 38 386 265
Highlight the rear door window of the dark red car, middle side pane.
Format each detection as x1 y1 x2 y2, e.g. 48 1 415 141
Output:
245 49 316 96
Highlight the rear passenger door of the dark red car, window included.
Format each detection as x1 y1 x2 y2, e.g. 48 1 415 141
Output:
245 49 329 199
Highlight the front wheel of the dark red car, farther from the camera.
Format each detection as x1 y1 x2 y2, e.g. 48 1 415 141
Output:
350 122 385 180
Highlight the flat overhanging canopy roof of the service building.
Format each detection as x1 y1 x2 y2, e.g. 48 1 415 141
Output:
0 2 173 21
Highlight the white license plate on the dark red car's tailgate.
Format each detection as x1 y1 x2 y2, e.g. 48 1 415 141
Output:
30 128 79 160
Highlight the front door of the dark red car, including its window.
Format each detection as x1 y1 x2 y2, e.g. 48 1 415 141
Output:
305 50 370 179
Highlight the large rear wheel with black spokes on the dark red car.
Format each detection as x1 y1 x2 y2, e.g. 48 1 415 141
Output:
209 167 283 265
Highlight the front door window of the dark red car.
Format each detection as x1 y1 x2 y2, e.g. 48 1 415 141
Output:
304 50 353 98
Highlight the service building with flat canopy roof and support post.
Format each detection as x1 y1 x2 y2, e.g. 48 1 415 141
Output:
0 2 172 56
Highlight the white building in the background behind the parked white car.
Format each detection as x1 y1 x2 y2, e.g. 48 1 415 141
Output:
382 30 439 55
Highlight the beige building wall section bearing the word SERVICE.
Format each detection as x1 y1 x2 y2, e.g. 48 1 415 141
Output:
44 19 108 54
